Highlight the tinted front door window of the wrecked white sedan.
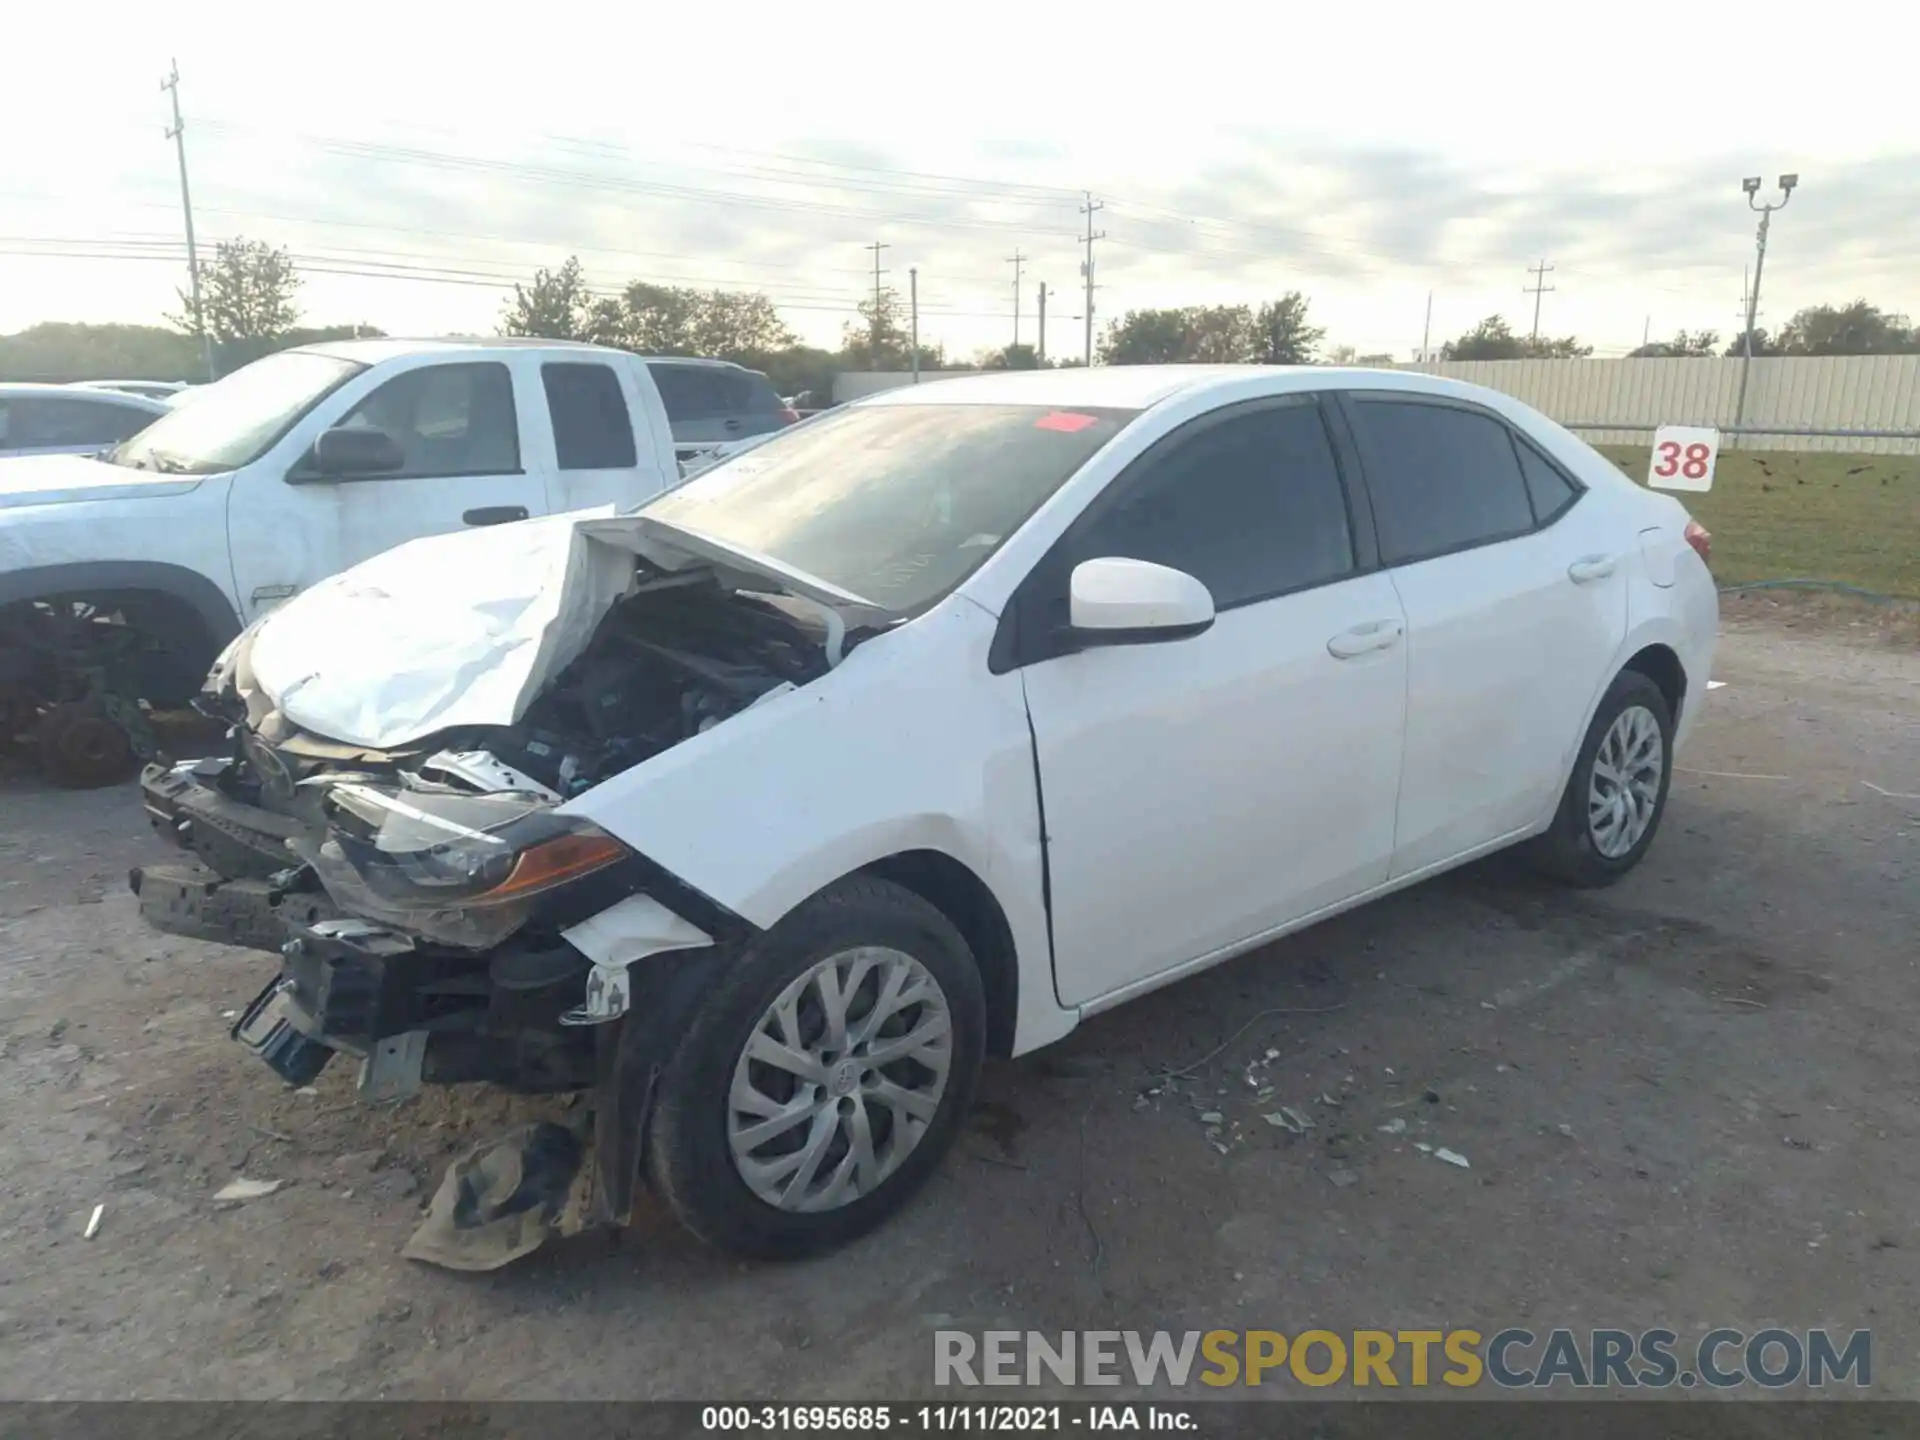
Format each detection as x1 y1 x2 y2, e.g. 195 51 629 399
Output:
1064 396 1354 609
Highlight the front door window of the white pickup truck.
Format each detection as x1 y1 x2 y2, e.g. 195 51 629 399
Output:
322 361 520 480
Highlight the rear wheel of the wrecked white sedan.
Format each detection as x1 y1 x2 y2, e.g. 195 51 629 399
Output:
1530 670 1674 887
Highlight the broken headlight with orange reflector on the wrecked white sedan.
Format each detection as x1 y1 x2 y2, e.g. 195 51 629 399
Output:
300 783 628 950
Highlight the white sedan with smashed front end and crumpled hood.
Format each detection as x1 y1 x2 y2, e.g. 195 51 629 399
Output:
142 367 1718 1256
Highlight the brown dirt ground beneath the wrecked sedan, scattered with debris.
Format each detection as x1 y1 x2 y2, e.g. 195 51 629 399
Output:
0 607 1920 1400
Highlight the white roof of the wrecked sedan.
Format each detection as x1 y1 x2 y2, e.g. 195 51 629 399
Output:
852 365 1488 411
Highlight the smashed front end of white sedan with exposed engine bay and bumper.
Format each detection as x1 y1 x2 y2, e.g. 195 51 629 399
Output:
131 526 864 1221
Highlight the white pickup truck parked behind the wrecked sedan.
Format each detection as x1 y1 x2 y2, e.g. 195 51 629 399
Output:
0 340 682 785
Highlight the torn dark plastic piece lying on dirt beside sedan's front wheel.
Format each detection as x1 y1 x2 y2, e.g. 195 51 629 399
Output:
399 1119 593 1271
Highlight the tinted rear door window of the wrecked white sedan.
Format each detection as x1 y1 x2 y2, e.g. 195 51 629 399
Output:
1354 397 1534 564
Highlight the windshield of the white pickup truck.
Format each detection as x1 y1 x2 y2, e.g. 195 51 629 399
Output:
102 349 367 474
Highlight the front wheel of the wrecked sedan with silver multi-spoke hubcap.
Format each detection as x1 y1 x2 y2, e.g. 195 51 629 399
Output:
647 877 987 1260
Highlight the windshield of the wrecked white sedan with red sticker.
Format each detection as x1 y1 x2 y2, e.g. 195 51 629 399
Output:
641 403 1137 614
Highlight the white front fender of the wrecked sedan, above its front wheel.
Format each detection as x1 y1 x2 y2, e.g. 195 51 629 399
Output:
563 597 1073 1054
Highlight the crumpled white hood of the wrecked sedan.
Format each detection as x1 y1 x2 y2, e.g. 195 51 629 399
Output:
241 507 885 751
